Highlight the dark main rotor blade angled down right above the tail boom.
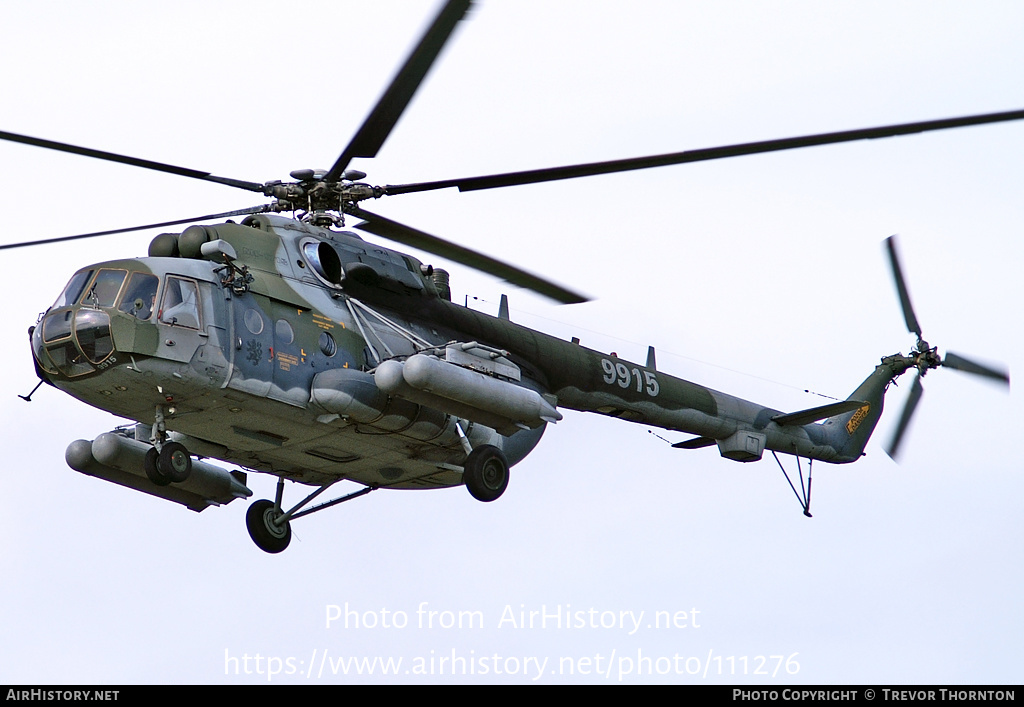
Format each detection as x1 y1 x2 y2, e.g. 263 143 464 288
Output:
350 208 588 304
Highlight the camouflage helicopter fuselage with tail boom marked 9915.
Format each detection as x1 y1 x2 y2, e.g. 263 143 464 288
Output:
32 216 881 488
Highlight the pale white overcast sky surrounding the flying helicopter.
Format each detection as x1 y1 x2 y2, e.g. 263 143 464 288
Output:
0 0 1024 684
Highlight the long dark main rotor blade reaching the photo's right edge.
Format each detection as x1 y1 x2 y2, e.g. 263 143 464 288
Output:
385 106 1024 194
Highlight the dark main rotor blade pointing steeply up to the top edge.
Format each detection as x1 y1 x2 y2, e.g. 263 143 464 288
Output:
325 0 471 181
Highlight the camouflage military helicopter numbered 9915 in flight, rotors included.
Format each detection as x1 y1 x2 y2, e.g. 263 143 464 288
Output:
0 0 1007 552
